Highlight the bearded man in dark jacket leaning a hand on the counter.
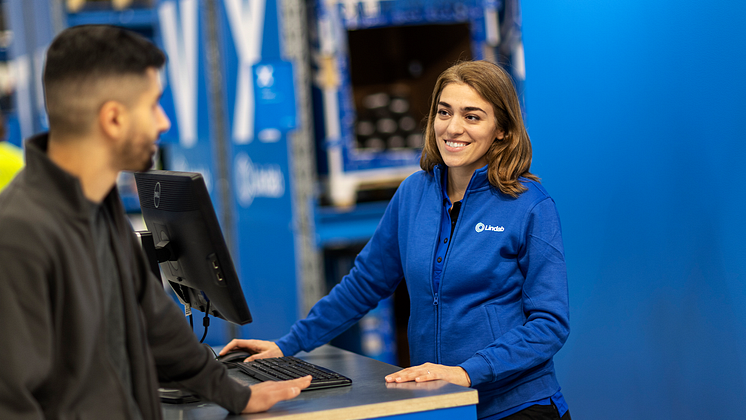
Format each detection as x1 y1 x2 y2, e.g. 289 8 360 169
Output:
0 26 310 420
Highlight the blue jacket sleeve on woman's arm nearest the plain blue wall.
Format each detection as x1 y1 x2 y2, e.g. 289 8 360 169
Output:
460 198 570 386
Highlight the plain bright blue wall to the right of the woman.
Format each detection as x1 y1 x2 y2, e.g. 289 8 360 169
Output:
522 0 746 420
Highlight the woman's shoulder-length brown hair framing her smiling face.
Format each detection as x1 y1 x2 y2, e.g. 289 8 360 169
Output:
420 61 539 197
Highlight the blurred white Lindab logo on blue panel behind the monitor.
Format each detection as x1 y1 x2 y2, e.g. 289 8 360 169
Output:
234 152 285 207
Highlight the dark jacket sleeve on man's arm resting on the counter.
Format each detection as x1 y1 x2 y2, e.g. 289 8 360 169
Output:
135 238 251 413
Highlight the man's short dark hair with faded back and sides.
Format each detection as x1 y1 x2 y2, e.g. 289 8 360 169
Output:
43 25 166 135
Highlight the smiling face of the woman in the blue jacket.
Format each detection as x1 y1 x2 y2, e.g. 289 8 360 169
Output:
433 83 505 173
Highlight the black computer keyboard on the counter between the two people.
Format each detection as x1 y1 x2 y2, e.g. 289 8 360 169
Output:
236 356 352 391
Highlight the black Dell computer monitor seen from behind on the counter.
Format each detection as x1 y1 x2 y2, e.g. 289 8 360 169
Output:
135 170 251 325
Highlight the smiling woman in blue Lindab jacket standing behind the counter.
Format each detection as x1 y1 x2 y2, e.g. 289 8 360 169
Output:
222 61 570 420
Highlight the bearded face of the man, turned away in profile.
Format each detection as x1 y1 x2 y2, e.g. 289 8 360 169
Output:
117 68 171 171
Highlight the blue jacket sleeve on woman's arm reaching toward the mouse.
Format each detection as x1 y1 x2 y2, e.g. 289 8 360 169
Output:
277 193 404 356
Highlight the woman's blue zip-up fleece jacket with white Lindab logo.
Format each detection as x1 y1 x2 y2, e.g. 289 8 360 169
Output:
277 166 569 417
